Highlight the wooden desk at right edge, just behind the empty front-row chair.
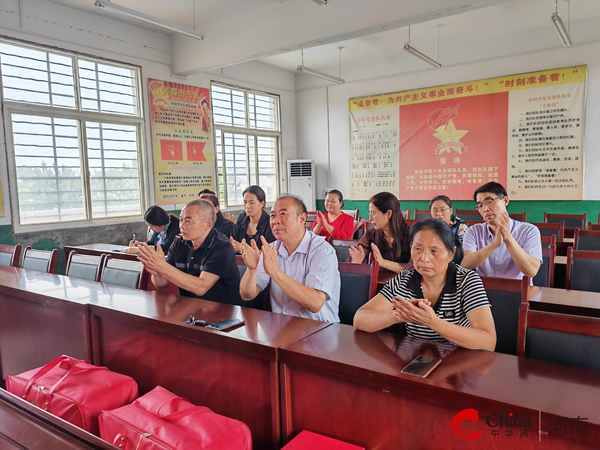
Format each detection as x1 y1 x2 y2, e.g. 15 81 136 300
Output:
529 286 600 317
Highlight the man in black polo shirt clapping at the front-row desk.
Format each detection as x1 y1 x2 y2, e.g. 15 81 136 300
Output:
138 199 240 304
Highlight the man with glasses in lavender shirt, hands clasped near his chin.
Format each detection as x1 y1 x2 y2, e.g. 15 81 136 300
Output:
461 182 542 279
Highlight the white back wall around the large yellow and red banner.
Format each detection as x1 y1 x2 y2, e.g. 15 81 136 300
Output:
296 44 600 200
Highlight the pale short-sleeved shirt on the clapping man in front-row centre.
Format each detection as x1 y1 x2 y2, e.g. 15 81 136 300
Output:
256 230 340 323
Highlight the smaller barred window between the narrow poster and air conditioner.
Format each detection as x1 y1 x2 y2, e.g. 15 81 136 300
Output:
211 83 281 207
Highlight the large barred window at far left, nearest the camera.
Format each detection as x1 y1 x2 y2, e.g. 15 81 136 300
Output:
0 41 143 226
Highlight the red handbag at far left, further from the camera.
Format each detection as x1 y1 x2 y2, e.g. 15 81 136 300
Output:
6 355 138 435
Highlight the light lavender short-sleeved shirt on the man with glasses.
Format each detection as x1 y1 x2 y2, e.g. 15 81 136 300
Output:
463 219 543 280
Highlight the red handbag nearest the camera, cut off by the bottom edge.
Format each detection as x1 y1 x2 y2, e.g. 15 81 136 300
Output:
99 386 252 450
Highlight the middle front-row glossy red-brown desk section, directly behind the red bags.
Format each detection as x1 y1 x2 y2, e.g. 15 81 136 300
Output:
90 291 330 449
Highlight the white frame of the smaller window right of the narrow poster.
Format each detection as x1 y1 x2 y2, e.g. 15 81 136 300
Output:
210 80 282 210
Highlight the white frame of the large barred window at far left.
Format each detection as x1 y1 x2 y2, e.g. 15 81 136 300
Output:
0 39 149 233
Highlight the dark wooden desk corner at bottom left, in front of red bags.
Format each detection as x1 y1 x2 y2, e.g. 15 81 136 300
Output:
0 389 116 450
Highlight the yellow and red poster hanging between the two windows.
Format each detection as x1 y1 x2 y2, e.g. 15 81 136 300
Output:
148 78 215 205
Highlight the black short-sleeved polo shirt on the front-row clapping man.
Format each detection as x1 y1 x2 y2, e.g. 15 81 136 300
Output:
167 228 241 305
